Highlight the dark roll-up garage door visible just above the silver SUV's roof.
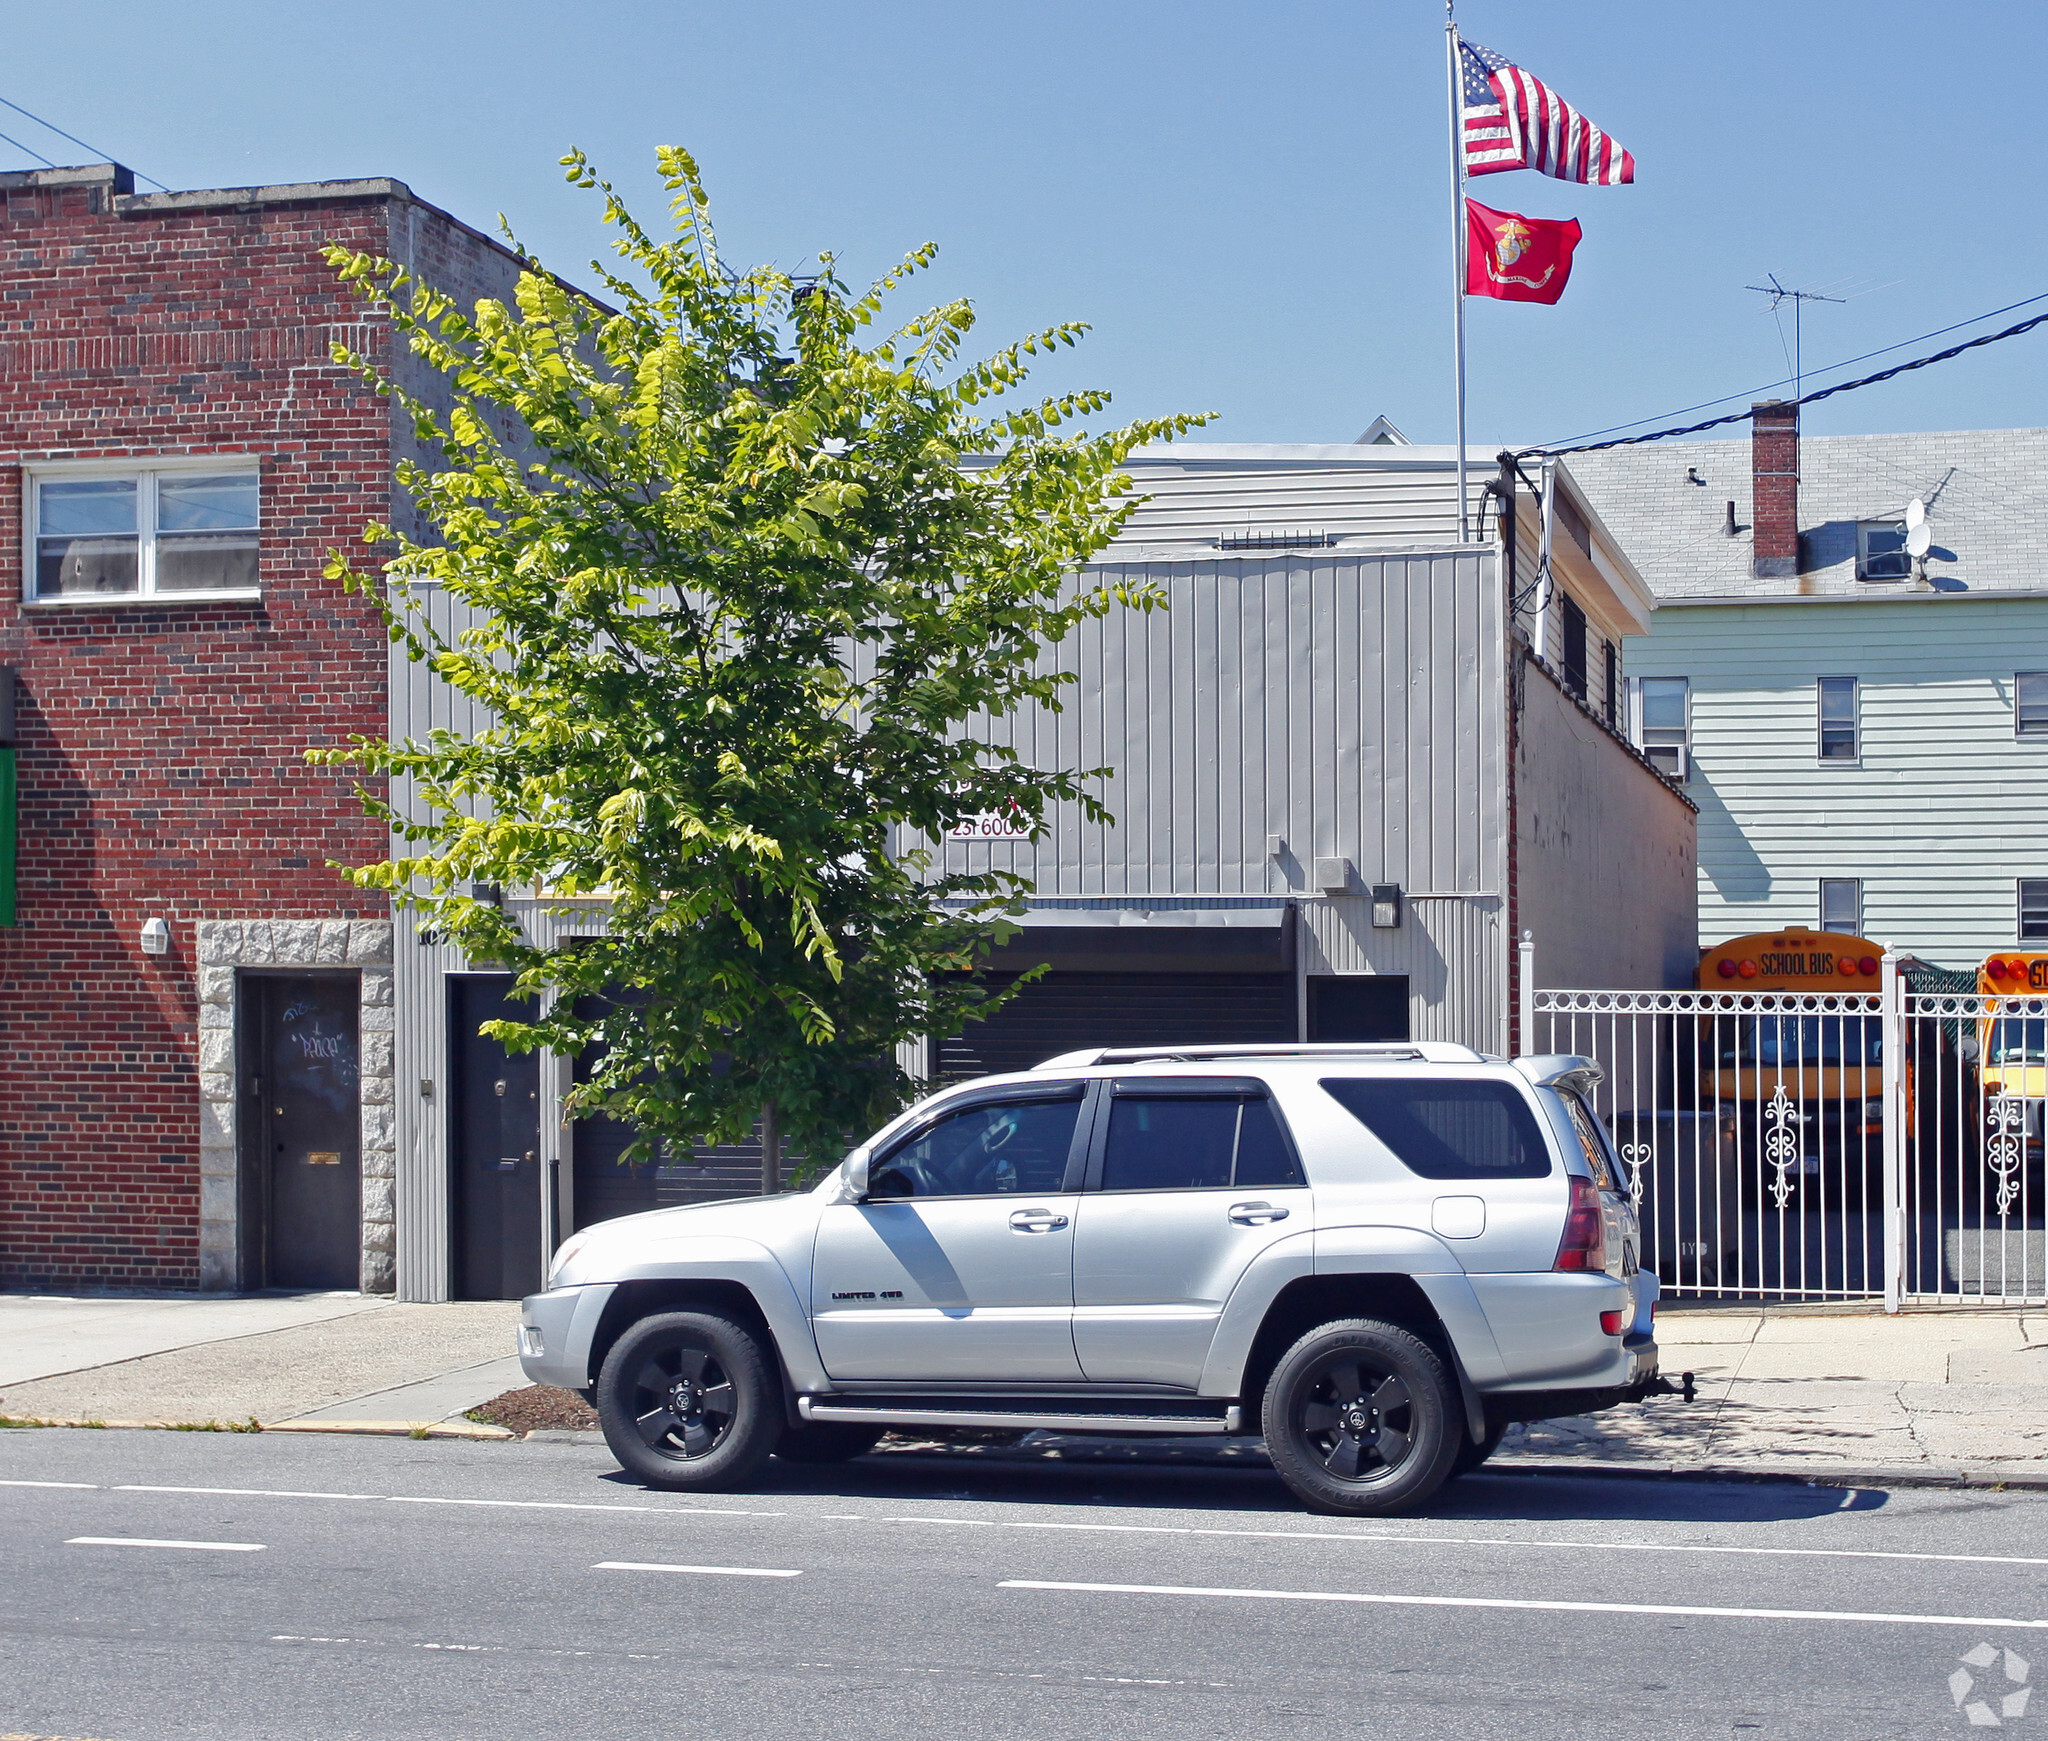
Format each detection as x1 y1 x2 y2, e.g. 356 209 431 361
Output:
938 971 1296 1077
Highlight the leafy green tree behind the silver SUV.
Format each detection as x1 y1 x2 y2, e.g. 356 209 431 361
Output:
311 147 1200 1167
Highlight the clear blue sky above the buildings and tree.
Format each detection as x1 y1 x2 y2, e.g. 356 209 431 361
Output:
0 0 2048 442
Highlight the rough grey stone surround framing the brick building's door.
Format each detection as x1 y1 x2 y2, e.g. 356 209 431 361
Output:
199 920 397 1294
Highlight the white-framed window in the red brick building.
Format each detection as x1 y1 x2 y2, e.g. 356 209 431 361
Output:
23 455 262 604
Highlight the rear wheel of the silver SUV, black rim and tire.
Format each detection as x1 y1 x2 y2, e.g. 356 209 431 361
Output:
1260 1317 1466 1518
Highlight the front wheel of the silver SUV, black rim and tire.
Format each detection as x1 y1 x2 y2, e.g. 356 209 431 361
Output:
598 1311 782 1491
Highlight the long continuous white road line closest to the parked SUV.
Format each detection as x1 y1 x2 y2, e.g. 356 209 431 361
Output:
56 1481 2048 1565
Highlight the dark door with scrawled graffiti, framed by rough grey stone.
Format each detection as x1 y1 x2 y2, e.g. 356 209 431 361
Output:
240 973 362 1288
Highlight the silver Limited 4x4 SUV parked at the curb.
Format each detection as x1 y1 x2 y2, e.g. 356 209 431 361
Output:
520 1043 1663 1514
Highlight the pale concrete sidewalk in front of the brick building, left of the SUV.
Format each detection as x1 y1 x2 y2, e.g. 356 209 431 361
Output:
0 1294 526 1436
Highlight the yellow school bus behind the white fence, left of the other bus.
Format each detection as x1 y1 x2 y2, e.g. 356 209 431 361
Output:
1694 926 1884 1176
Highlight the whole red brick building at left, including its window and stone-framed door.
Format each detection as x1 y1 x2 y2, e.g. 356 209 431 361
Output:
0 164 518 1290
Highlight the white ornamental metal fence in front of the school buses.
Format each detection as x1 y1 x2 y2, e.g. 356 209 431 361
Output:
1524 970 2048 1309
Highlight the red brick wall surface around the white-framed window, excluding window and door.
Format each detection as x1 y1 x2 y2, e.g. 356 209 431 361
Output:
0 170 510 1286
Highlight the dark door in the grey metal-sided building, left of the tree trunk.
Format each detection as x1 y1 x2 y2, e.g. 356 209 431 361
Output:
449 975 543 1301
